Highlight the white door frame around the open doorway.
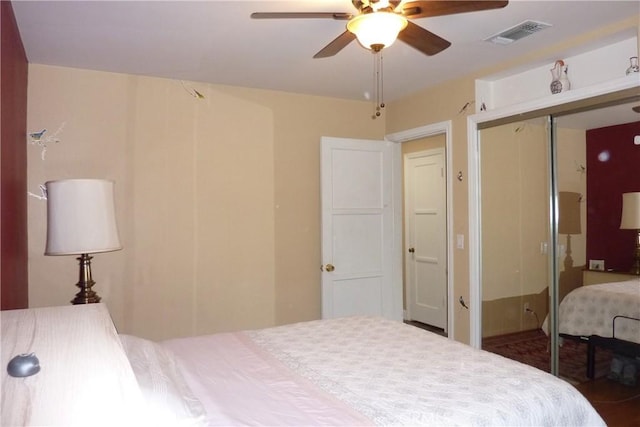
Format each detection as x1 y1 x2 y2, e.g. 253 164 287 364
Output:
385 120 455 339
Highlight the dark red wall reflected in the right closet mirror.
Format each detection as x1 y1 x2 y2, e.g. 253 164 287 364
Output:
586 121 640 272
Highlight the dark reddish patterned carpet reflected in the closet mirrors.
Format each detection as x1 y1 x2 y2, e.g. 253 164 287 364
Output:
482 329 612 384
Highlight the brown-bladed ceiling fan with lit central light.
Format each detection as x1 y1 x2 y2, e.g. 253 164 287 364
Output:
251 0 509 58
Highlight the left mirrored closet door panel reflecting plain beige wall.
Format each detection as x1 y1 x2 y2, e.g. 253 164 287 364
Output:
480 117 553 371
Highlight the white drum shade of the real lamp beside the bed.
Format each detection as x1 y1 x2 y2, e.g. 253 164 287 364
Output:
45 179 122 255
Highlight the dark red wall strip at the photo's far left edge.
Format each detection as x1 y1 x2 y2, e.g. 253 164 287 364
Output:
0 1 29 310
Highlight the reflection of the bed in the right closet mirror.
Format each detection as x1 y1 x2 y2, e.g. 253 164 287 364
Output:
543 277 640 378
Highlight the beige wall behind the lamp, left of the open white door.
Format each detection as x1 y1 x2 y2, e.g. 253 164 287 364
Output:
28 64 384 339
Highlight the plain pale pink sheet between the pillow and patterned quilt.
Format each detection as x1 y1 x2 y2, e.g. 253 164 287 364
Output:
162 333 372 426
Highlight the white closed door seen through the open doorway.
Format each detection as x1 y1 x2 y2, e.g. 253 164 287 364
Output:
405 148 447 331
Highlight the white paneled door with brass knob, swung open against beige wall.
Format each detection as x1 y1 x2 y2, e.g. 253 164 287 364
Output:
321 137 402 319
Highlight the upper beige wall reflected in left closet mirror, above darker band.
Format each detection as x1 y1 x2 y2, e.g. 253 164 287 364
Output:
480 119 549 302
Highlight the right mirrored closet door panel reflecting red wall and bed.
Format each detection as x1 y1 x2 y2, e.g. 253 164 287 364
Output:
554 101 640 385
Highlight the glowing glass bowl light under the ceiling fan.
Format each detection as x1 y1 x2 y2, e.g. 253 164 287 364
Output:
347 12 407 51
